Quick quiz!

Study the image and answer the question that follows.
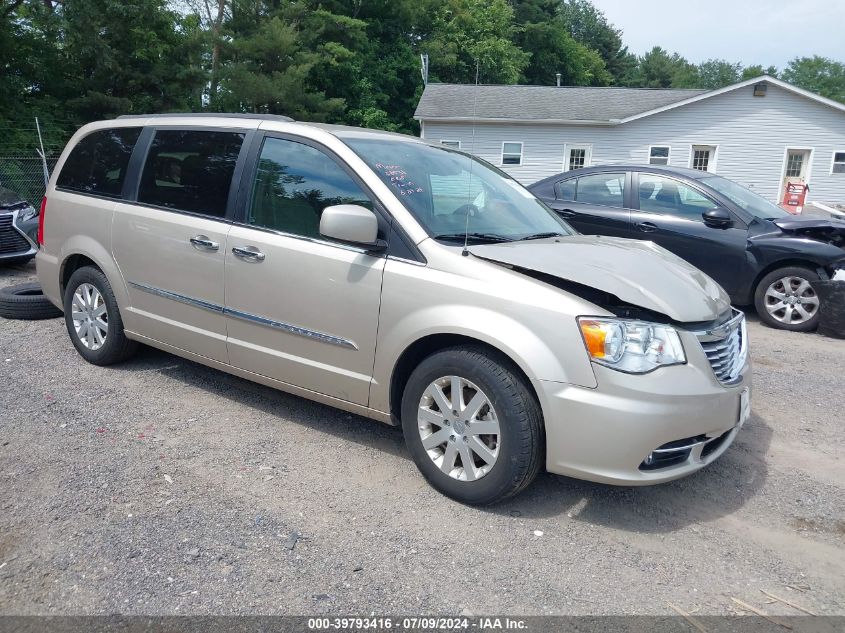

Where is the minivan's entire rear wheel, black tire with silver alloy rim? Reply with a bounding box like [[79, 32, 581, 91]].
[[64, 266, 138, 365]]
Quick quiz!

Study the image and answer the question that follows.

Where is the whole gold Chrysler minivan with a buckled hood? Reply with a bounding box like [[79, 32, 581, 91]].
[[37, 115, 751, 504]]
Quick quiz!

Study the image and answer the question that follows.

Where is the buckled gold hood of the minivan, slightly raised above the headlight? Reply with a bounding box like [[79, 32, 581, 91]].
[[469, 235, 730, 322]]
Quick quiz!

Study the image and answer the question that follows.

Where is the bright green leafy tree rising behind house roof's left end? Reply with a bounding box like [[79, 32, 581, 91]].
[[426, 0, 530, 84]]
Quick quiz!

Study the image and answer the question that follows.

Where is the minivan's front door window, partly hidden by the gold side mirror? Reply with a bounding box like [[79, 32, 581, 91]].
[[247, 138, 373, 237]]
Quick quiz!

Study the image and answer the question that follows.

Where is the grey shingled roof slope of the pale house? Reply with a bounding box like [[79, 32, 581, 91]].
[[414, 83, 707, 122]]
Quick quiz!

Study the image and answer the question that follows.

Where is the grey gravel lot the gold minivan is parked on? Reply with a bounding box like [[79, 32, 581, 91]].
[[0, 256, 845, 615]]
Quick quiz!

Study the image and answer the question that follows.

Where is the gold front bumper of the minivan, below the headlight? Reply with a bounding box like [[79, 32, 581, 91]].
[[534, 334, 751, 485]]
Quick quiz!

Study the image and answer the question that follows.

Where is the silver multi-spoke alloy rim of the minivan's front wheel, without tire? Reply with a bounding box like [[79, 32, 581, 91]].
[[417, 376, 500, 481]]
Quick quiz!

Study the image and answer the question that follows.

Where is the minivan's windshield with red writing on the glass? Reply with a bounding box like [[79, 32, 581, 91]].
[[343, 137, 575, 242]]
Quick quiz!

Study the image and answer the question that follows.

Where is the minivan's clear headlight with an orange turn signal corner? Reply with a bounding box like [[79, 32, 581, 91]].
[[578, 317, 687, 374]]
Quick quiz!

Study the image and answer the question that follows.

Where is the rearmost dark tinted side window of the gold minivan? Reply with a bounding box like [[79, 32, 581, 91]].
[[56, 127, 141, 198]]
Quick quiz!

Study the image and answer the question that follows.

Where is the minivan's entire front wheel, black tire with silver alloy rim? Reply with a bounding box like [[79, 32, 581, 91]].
[[402, 347, 544, 505]]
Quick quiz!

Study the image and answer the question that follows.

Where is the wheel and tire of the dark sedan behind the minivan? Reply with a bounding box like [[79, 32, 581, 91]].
[[754, 266, 819, 332]]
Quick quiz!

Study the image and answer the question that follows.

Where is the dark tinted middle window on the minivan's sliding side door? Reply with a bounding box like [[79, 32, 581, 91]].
[[138, 130, 244, 218]]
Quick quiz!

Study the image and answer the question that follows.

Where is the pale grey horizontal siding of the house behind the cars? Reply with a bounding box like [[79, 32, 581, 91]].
[[423, 84, 845, 203]]
